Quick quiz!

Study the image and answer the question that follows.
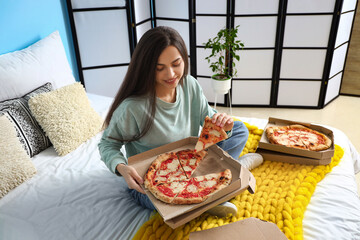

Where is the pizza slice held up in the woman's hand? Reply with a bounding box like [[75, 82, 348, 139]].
[[195, 116, 228, 151]]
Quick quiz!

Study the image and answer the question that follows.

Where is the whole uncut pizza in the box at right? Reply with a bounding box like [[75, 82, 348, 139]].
[[265, 125, 332, 151]]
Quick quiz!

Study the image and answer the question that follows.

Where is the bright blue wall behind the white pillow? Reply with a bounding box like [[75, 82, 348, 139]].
[[0, 0, 79, 81]]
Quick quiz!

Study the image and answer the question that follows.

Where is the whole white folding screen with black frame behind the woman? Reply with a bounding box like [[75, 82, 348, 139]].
[[68, 0, 357, 108]]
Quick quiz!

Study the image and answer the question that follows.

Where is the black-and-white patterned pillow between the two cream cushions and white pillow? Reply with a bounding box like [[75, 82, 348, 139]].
[[0, 83, 52, 157]]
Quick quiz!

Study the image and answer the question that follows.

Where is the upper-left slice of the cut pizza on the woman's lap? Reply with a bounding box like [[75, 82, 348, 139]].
[[144, 152, 187, 189]]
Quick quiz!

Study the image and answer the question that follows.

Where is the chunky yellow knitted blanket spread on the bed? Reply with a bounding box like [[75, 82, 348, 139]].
[[133, 122, 344, 240]]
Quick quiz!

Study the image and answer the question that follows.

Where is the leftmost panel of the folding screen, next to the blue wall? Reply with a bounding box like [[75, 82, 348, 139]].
[[67, 0, 132, 97]]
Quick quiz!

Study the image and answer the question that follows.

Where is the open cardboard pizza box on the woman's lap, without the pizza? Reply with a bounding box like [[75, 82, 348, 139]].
[[128, 137, 255, 228]]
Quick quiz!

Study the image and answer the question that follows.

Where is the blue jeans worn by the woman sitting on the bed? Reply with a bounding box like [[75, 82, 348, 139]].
[[129, 121, 249, 210]]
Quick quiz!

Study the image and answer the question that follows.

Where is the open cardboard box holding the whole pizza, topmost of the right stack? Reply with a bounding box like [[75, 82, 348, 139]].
[[258, 117, 335, 159]]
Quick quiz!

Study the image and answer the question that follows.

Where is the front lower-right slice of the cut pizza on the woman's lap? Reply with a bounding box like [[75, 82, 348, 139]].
[[172, 169, 232, 204]]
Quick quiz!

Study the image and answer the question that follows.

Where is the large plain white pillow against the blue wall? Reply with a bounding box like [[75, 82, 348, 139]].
[[0, 31, 75, 101]]
